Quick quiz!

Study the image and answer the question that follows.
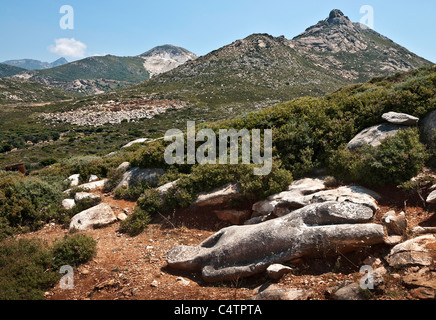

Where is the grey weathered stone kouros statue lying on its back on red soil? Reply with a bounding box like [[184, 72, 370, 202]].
[[167, 201, 385, 282]]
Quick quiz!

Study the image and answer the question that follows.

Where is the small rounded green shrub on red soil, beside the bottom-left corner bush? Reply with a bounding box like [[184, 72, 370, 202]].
[[52, 234, 97, 268]]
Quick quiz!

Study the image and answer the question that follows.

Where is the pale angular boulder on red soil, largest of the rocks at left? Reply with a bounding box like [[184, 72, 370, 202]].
[[70, 203, 117, 231]]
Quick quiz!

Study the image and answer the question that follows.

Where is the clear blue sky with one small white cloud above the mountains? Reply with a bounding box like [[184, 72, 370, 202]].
[[0, 0, 436, 62]]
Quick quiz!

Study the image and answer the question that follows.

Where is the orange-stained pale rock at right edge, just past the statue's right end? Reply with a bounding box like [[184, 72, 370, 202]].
[[386, 234, 436, 267]]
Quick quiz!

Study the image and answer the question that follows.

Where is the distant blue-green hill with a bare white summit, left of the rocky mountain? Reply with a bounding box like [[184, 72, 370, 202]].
[[5, 45, 197, 95]]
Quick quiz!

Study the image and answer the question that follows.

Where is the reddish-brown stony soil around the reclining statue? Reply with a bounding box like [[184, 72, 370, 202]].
[[13, 175, 436, 300]]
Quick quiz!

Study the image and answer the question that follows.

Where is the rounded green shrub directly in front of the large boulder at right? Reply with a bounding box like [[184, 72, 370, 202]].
[[330, 129, 427, 185]]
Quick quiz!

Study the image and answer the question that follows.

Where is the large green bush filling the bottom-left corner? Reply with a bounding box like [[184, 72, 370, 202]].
[[0, 239, 61, 300]]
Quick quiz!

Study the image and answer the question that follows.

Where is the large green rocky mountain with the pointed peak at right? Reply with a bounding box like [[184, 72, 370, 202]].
[[108, 10, 432, 117]]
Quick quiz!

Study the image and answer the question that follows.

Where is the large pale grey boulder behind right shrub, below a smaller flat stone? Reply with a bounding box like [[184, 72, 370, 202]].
[[347, 123, 408, 150]]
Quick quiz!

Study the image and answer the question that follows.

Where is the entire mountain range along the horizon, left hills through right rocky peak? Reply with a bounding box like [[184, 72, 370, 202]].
[[0, 10, 432, 105]]
